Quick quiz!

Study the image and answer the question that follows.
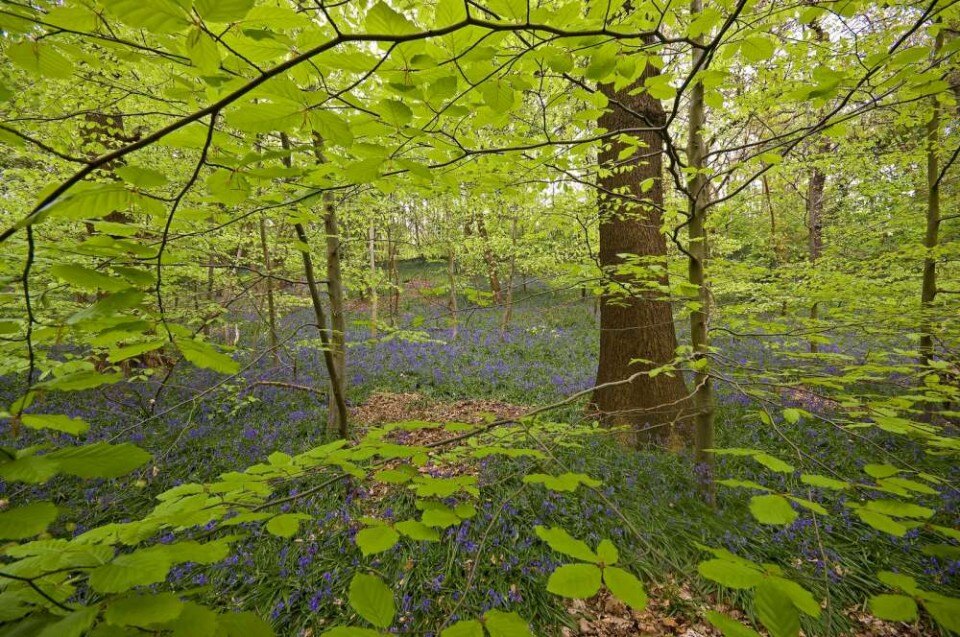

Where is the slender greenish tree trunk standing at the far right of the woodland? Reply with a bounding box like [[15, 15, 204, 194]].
[[920, 30, 943, 366]]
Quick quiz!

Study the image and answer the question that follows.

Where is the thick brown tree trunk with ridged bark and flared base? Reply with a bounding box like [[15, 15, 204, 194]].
[[593, 41, 689, 444]]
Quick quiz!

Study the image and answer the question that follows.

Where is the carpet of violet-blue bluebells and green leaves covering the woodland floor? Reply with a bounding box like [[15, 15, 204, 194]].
[[0, 264, 960, 634]]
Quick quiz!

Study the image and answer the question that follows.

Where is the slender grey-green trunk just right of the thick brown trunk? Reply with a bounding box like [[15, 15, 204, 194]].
[[687, 0, 716, 505]]
